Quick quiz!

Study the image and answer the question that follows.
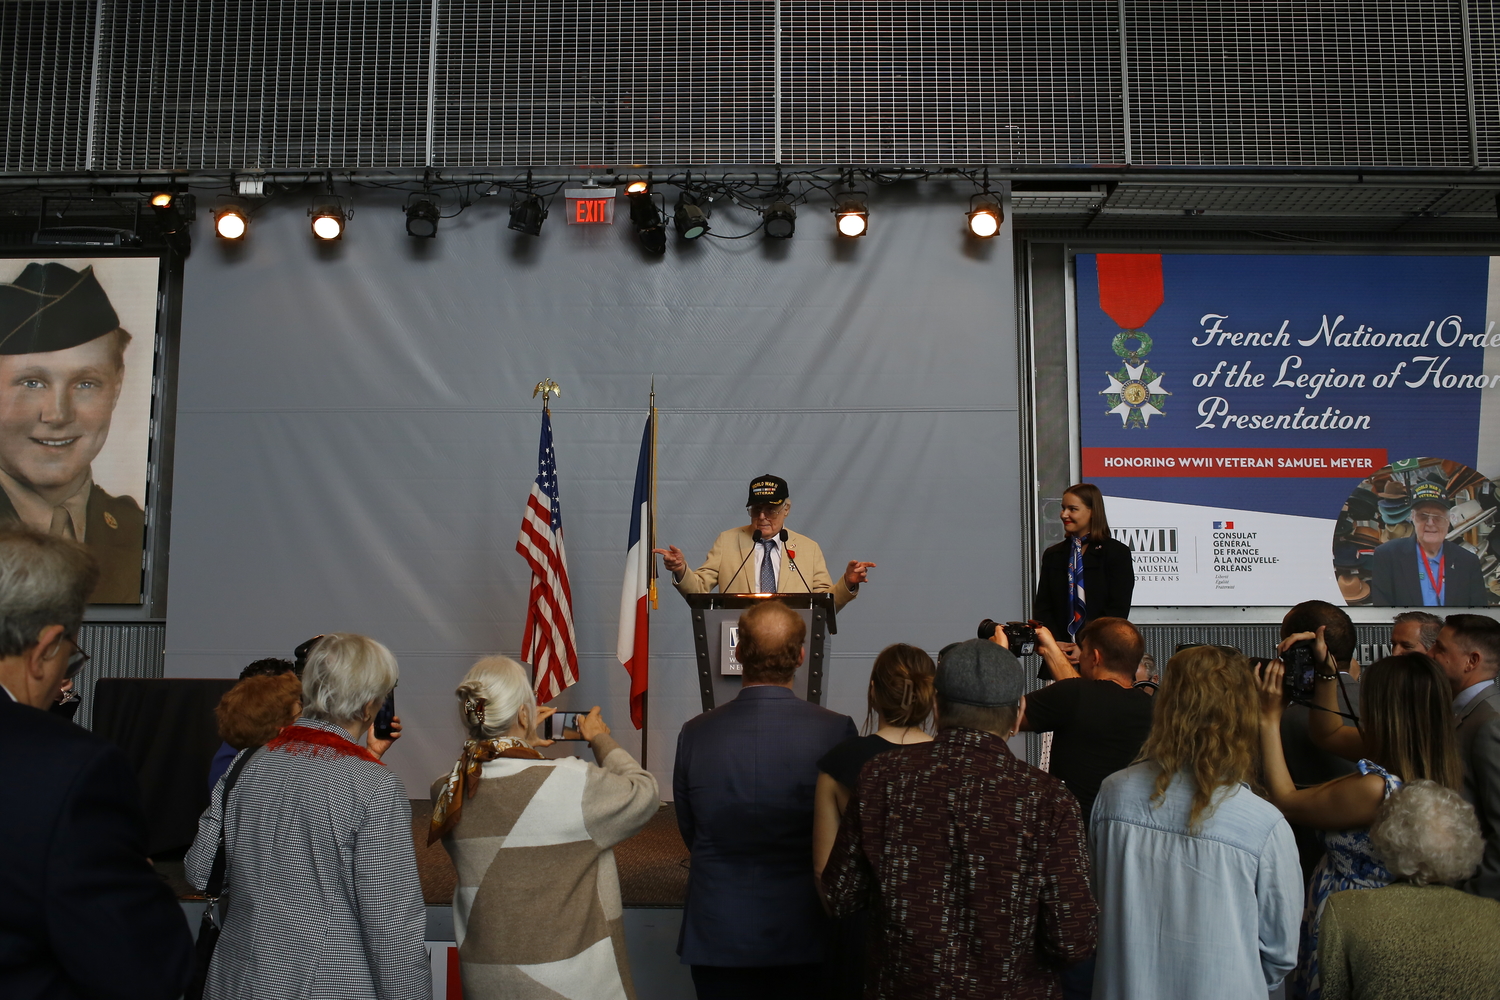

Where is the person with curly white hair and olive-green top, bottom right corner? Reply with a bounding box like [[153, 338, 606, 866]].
[[1319, 781, 1500, 1000]]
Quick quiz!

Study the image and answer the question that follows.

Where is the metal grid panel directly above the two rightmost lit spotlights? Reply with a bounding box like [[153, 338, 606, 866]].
[[783, 0, 1124, 163]]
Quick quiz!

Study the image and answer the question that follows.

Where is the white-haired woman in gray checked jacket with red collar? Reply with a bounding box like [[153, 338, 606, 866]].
[[188, 633, 432, 1000]]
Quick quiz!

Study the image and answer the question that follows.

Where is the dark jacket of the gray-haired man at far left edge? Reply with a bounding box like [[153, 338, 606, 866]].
[[0, 691, 192, 1000]]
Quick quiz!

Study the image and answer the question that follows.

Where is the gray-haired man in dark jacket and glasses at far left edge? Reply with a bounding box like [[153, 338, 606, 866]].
[[0, 528, 192, 1000]]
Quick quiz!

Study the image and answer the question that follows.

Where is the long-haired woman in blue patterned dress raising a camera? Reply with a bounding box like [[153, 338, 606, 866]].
[[1257, 641, 1463, 1000]]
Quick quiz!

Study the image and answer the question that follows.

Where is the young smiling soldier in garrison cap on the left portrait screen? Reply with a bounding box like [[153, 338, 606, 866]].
[[0, 262, 146, 604]]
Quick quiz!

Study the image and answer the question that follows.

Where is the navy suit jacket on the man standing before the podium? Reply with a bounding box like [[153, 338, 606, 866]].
[[672, 687, 857, 966]]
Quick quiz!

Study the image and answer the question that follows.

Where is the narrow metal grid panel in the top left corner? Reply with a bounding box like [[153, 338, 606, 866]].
[[0, 1, 95, 172]]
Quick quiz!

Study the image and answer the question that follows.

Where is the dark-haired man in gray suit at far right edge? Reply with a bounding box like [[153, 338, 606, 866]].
[[1433, 615, 1500, 900]]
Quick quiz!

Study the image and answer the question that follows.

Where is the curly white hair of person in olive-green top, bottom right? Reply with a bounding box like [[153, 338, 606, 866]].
[[1370, 781, 1485, 886]]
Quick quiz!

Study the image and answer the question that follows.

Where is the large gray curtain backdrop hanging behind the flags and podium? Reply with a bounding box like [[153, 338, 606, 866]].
[[167, 186, 1026, 798]]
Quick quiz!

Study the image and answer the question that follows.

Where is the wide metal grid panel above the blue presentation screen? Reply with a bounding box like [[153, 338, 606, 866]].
[[1125, 0, 1470, 166]]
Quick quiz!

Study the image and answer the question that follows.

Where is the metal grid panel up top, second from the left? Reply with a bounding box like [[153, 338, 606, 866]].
[[93, 0, 431, 169]]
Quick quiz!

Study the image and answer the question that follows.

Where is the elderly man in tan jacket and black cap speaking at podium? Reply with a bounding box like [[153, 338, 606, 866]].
[[654, 475, 875, 610]]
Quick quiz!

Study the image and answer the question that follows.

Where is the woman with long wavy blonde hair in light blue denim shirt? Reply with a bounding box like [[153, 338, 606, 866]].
[[1089, 646, 1302, 1000]]
